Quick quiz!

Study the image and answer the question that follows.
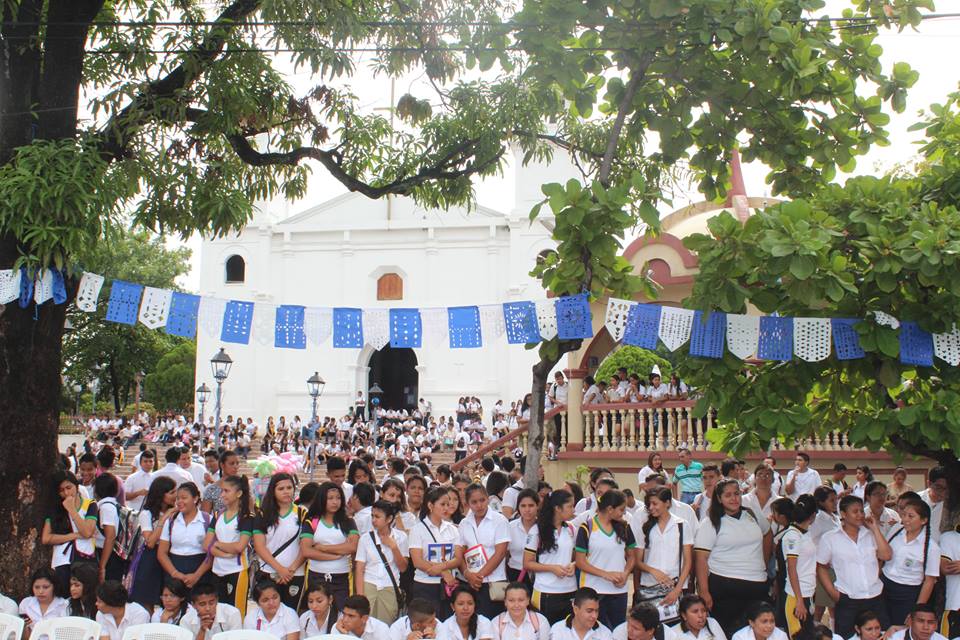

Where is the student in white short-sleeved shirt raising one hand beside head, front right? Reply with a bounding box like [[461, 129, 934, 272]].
[[817, 495, 893, 638]]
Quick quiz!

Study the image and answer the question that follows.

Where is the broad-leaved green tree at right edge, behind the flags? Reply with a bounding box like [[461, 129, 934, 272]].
[[681, 94, 960, 528]]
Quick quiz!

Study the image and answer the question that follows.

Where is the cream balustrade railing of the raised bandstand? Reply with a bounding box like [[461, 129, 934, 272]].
[[572, 400, 854, 452]]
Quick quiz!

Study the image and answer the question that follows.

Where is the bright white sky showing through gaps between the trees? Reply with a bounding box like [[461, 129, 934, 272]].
[[169, 6, 960, 291]]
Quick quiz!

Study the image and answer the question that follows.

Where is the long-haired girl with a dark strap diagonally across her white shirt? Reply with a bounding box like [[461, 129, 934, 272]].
[[253, 473, 307, 610]]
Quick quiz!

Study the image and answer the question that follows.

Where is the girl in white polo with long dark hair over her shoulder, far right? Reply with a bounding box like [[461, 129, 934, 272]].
[[880, 497, 940, 624]]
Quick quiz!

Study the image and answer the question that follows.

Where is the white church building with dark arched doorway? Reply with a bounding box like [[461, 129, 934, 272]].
[[196, 151, 577, 424]]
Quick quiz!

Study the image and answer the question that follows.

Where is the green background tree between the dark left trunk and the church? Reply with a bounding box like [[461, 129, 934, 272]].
[[63, 230, 193, 413]]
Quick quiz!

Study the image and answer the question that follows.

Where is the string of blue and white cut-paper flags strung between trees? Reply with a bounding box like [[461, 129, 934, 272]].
[[7, 269, 960, 367]]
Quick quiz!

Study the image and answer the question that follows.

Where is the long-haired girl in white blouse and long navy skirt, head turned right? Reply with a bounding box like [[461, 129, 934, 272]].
[[130, 476, 178, 611]]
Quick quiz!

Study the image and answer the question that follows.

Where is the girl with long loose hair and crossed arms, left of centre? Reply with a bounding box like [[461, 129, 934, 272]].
[[300, 482, 360, 611]]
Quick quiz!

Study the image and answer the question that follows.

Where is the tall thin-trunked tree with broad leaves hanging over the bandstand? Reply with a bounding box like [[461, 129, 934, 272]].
[[506, 0, 932, 486]]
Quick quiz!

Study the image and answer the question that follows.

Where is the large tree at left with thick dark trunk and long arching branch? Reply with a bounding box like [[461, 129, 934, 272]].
[[0, 0, 556, 595]]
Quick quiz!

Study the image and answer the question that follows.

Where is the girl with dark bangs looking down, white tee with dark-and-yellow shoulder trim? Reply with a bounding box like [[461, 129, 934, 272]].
[[576, 489, 637, 629]]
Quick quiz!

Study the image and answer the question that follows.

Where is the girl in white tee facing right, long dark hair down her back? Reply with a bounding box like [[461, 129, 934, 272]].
[[523, 489, 577, 625]]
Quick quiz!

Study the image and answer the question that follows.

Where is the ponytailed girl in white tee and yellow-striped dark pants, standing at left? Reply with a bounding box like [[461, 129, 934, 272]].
[[203, 476, 253, 615]]
